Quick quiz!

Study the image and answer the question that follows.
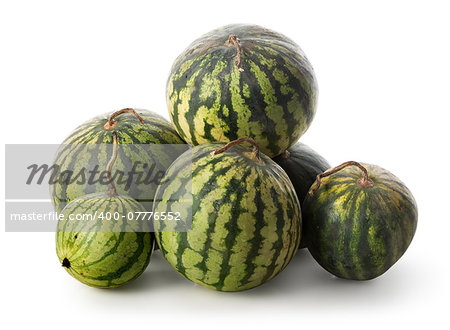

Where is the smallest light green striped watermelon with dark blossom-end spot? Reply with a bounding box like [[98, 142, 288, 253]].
[[56, 193, 153, 288]]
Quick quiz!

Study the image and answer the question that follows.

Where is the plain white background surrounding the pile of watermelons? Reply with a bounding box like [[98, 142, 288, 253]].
[[0, 0, 450, 329]]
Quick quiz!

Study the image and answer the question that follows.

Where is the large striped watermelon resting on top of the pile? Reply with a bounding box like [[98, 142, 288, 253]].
[[166, 24, 318, 157]]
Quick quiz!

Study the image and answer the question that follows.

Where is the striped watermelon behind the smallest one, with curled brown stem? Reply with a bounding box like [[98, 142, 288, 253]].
[[50, 109, 186, 212]]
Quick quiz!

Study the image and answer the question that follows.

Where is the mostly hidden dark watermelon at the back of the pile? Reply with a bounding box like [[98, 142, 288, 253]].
[[273, 142, 331, 249]]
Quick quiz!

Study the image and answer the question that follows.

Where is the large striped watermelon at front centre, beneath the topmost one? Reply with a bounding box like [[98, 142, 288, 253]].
[[154, 139, 301, 291]]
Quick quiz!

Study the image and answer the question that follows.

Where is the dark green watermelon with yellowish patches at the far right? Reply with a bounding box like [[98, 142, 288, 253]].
[[303, 162, 417, 280]]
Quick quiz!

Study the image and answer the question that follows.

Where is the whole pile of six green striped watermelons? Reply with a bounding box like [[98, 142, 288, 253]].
[[51, 25, 418, 291]]
